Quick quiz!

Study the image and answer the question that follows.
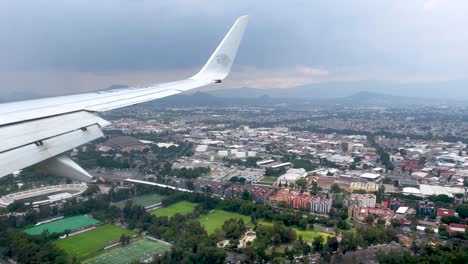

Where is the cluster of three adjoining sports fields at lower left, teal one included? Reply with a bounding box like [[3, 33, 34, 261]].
[[24, 215, 171, 263]]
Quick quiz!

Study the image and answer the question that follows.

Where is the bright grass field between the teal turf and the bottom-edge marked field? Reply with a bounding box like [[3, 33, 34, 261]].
[[54, 225, 135, 260]]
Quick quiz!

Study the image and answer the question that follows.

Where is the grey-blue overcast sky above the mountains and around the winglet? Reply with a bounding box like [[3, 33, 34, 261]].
[[0, 0, 468, 97]]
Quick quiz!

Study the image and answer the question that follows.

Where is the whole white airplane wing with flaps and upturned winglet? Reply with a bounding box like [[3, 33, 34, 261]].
[[0, 16, 248, 182]]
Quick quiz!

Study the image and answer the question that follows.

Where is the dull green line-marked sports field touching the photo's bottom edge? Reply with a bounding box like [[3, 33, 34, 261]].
[[84, 238, 171, 264]]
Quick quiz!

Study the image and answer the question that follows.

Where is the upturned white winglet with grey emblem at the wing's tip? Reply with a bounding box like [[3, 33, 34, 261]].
[[190, 16, 249, 82]]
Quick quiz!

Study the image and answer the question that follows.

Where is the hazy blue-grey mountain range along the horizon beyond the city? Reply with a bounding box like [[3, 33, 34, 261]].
[[0, 81, 468, 106]]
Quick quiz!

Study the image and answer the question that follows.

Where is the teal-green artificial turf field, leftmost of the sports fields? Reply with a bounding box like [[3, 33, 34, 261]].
[[24, 215, 100, 235]]
